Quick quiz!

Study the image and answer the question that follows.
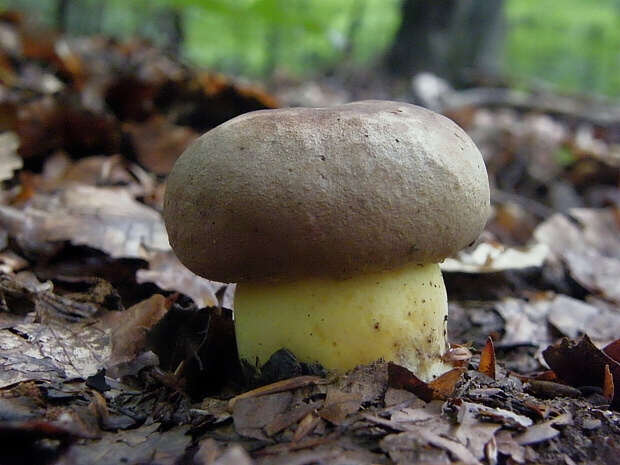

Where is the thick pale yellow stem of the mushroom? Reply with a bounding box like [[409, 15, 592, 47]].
[[234, 264, 451, 381]]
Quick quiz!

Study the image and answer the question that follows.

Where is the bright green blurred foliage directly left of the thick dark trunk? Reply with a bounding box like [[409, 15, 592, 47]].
[[175, 0, 400, 76]]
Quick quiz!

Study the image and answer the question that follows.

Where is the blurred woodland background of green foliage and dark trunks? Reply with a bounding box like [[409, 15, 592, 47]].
[[0, 0, 620, 97]]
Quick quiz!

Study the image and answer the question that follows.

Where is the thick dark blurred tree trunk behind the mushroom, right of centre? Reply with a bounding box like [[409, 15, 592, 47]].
[[384, 0, 505, 85]]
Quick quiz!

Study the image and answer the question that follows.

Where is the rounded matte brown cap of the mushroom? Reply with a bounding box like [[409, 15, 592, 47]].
[[164, 101, 489, 282]]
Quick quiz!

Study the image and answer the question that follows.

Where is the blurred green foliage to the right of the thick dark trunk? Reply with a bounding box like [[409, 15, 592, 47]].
[[506, 0, 620, 96]]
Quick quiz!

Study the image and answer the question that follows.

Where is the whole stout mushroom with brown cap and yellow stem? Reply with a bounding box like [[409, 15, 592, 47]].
[[164, 101, 489, 380]]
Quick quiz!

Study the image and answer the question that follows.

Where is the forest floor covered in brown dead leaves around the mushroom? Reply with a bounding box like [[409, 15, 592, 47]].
[[0, 15, 620, 465]]
